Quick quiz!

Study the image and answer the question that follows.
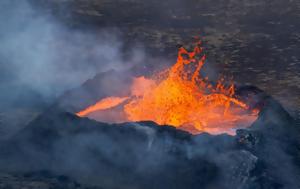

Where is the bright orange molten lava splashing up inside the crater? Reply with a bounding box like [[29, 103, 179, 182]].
[[77, 42, 257, 134]]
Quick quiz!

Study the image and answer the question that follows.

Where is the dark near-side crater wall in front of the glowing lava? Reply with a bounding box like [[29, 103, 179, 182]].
[[0, 86, 300, 189]]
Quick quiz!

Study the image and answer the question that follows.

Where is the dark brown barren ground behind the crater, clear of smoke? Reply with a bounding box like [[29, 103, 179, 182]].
[[32, 0, 300, 115]]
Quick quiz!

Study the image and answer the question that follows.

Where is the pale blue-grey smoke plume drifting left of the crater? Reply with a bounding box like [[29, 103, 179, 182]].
[[0, 0, 145, 137]]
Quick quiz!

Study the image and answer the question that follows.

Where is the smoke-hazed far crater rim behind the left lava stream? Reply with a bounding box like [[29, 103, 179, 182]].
[[52, 70, 132, 112]]
